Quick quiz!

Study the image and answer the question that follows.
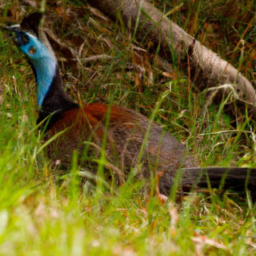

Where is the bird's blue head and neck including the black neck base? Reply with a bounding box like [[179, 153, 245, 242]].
[[15, 31, 79, 130]]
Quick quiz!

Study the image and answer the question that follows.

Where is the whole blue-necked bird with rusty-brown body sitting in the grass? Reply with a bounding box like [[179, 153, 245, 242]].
[[6, 13, 256, 200]]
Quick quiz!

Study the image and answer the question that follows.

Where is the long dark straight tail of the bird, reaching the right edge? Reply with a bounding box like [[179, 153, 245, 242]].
[[181, 167, 256, 202]]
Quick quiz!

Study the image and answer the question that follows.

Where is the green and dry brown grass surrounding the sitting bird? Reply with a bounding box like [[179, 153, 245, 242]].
[[0, 1, 256, 256]]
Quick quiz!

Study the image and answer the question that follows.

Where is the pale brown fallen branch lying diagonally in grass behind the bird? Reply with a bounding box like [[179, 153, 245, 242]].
[[88, 0, 256, 117]]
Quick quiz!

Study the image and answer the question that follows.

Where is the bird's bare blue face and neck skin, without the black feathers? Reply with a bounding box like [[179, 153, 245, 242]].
[[14, 30, 56, 107]]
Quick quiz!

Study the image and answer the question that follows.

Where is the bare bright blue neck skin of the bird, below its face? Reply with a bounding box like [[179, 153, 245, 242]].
[[30, 56, 56, 107]]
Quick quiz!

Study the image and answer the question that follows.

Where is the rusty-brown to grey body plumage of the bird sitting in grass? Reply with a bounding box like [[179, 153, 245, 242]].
[[48, 103, 195, 194]]
